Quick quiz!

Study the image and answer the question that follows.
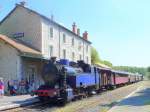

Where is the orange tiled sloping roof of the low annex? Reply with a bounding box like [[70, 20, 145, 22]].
[[0, 34, 41, 56]]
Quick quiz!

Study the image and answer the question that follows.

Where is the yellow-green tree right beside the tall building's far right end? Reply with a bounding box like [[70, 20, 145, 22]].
[[91, 47, 100, 64]]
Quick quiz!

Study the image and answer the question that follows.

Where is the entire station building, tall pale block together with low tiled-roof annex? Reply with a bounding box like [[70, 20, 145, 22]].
[[0, 4, 91, 92]]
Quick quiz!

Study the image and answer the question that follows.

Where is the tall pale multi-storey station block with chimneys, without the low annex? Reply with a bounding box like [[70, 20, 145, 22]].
[[0, 5, 91, 64]]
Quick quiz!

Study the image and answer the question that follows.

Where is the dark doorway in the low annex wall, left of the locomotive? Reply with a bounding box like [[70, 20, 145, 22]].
[[27, 66, 36, 89]]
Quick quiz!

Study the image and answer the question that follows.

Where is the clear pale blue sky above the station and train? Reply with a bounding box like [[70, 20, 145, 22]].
[[0, 0, 150, 67]]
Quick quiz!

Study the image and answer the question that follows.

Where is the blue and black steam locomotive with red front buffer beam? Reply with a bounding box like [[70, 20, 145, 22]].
[[34, 58, 99, 103]]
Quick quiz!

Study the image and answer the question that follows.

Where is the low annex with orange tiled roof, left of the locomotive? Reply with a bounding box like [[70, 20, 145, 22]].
[[0, 34, 43, 91]]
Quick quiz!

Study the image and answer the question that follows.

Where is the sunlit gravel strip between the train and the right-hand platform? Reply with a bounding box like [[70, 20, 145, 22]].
[[52, 82, 144, 112]]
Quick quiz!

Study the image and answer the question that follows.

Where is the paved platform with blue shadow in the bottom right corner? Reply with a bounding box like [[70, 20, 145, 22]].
[[108, 81, 150, 112]]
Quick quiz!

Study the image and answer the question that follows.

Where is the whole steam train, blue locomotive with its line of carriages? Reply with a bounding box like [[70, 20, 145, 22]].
[[34, 58, 143, 104]]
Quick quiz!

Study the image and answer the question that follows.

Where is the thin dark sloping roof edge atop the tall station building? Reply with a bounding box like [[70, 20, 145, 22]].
[[0, 4, 91, 44]]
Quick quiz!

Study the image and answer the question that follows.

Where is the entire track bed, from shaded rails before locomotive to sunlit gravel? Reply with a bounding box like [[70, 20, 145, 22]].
[[3, 82, 143, 112]]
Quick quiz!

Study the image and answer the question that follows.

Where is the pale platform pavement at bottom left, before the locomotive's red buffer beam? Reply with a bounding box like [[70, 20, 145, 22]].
[[0, 95, 39, 111]]
